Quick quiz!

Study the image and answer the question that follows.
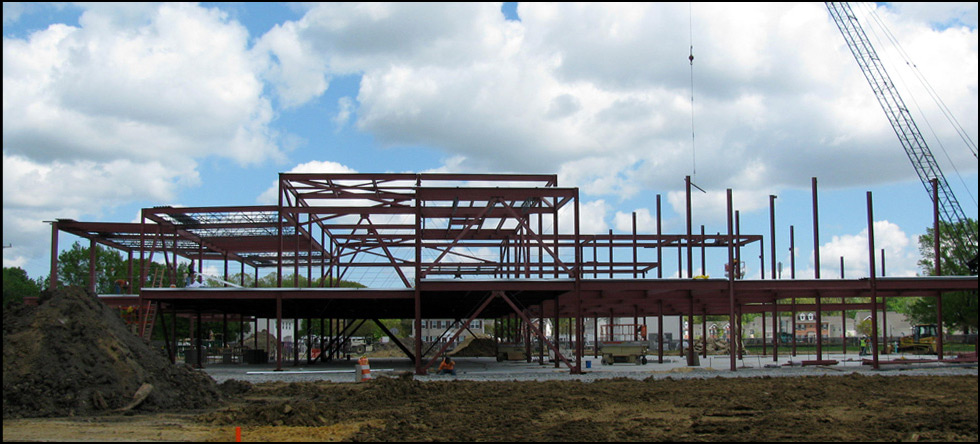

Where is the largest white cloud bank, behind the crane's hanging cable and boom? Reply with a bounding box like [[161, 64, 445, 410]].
[[256, 3, 977, 198]]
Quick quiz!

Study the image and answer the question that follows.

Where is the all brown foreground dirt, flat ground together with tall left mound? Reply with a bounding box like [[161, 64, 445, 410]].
[[3, 289, 978, 442]]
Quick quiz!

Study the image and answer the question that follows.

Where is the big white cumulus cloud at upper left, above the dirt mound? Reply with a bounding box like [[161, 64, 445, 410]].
[[3, 4, 282, 270]]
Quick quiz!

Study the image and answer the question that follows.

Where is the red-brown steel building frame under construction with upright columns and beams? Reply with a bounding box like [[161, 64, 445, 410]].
[[51, 173, 977, 374]]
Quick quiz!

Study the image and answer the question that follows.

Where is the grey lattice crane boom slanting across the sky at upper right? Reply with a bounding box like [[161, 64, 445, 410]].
[[825, 2, 977, 263]]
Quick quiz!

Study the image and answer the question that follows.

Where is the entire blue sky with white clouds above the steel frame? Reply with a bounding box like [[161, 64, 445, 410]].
[[3, 3, 978, 284]]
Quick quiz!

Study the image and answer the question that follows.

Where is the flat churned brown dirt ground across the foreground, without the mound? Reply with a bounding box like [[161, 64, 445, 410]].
[[3, 374, 978, 442]]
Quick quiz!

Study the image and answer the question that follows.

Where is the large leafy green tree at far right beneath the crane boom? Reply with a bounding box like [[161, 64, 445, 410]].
[[909, 219, 977, 332]]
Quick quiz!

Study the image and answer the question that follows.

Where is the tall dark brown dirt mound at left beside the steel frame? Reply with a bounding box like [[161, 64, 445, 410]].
[[3, 287, 219, 418]]
